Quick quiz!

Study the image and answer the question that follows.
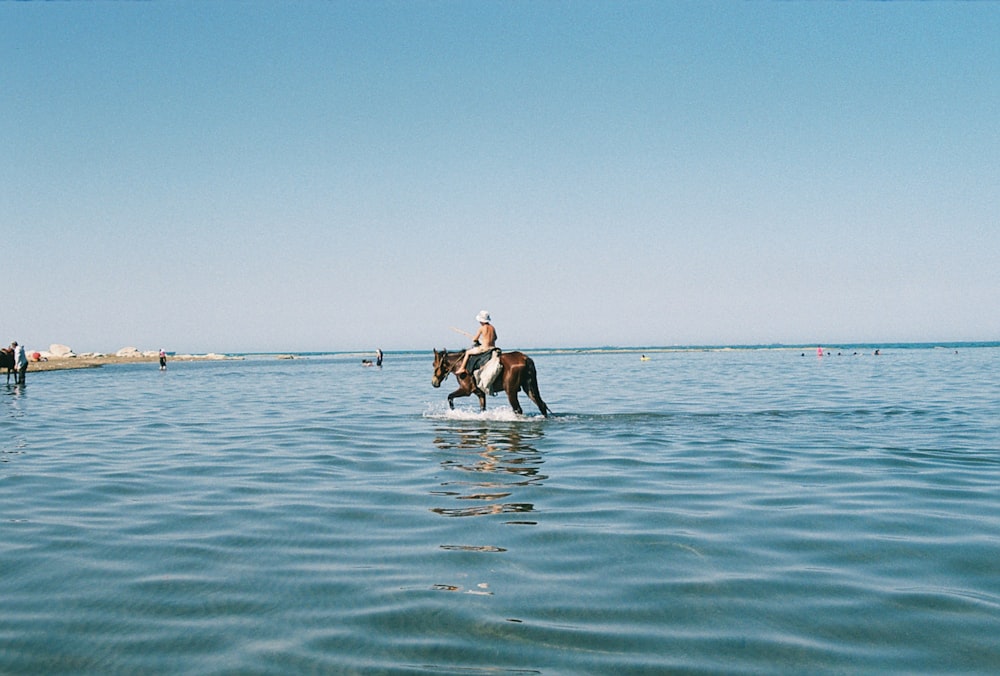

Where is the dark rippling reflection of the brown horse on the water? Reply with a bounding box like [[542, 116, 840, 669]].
[[431, 425, 548, 525]]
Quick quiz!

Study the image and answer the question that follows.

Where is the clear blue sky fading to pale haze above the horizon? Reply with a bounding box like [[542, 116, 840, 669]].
[[0, 0, 1000, 352]]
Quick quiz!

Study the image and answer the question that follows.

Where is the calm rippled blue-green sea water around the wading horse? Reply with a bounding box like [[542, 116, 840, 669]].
[[0, 345, 1000, 674]]
